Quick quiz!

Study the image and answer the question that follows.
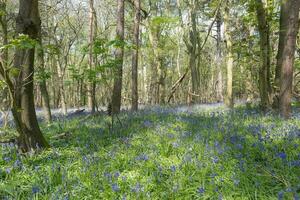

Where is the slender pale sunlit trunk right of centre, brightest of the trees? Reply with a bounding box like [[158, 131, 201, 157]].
[[224, 0, 234, 108]]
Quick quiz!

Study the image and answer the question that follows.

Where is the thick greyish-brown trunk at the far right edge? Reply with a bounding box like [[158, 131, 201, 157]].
[[278, 0, 300, 118]]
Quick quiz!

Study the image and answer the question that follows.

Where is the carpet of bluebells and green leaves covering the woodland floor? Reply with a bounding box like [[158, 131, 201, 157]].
[[0, 106, 300, 200]]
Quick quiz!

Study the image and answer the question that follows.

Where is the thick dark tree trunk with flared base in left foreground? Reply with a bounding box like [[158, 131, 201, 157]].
[[10, 0, 49, 152]]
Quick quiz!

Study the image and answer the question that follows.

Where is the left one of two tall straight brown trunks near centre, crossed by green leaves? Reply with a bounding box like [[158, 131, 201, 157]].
[[112, 0, 124, 114]]
